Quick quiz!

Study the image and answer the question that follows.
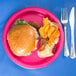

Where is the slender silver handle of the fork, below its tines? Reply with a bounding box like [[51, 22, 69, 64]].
[[64, 24, 69, 57]]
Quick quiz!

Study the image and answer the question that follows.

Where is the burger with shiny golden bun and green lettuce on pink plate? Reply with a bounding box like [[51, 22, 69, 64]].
[[7, 20, 38, 56]]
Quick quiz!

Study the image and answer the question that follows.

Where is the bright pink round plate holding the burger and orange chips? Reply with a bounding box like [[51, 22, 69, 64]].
[[2, 7, 64, 69]]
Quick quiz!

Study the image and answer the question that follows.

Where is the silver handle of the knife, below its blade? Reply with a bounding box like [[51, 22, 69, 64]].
[[70, 30, 75, 59]]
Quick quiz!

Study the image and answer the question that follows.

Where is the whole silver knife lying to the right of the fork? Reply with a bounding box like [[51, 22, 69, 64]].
[[69, 7, 75, 59]]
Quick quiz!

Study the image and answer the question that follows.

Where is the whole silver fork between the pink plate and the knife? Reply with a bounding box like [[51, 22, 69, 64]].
[[61, 8, 69, 57]]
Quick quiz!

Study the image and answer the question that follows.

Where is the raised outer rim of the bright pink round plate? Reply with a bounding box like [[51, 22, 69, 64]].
[[2, 7, 64, 69]]
